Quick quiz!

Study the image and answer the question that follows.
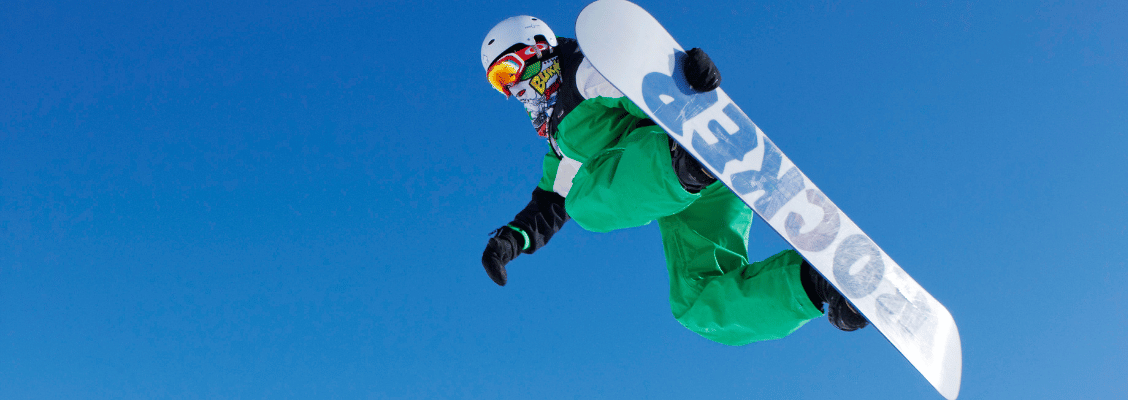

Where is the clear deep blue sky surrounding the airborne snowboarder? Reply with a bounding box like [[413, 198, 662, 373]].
[[0, 1, 1128, 399]]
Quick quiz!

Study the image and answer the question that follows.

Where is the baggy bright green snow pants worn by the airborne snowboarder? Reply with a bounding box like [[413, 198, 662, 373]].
[[565, 126, 822, 346]]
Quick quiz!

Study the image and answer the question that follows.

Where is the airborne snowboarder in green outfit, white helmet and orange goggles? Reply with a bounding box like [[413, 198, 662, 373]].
[[482, 16, 867, 345]]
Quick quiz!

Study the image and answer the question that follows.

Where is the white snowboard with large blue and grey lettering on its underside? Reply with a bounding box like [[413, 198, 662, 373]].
[[575, 0, 962, 399]]
